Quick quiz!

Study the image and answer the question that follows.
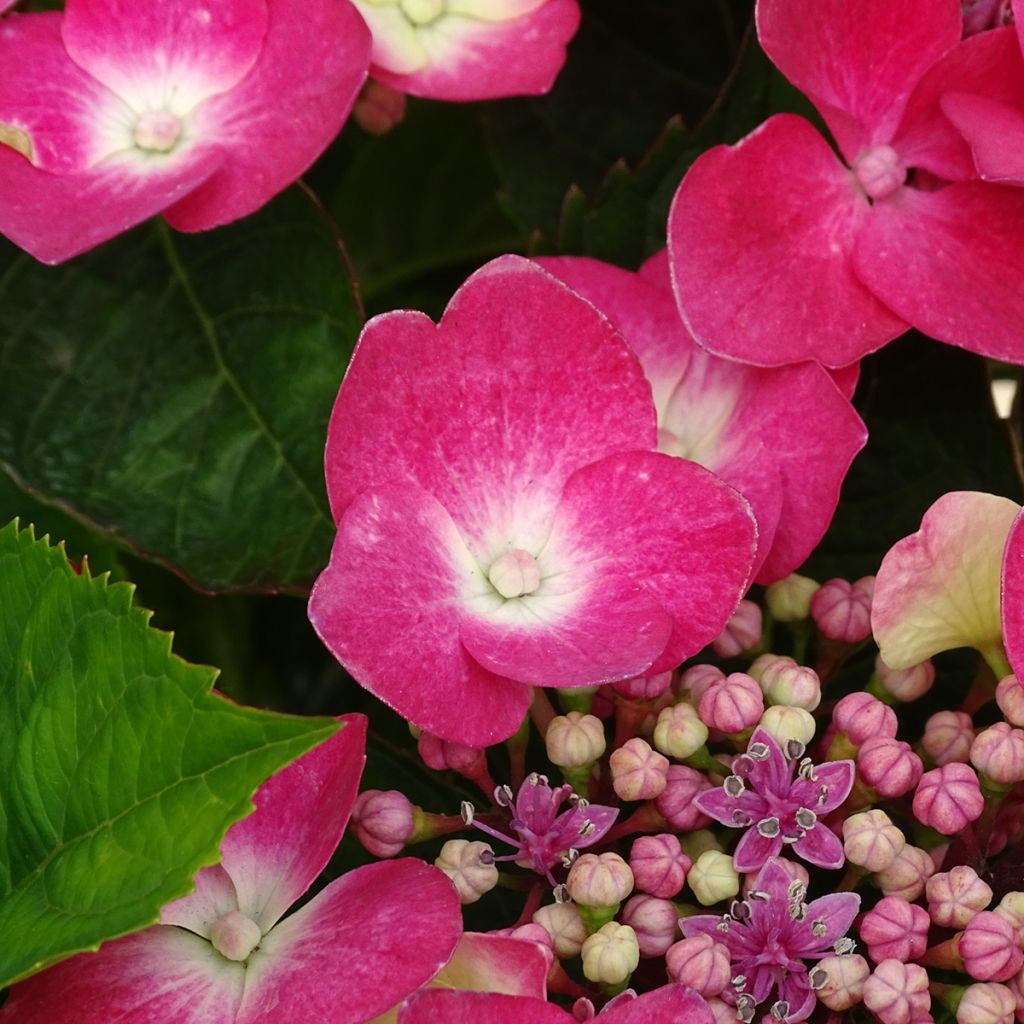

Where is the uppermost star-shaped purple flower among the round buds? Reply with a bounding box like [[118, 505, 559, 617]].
[[694, 728, 854, 872]]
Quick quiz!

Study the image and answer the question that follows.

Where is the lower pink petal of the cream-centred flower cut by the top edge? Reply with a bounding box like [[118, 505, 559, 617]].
[[371, 0, 580, 100]]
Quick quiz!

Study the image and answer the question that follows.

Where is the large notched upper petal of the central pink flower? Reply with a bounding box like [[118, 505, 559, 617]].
[[326, 256, 656, 552]]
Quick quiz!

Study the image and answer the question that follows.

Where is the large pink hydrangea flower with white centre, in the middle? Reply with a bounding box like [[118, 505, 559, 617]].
[[309, 256, 755, 746]]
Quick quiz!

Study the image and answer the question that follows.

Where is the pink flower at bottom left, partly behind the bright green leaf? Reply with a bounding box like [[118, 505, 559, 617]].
[[3, 715, 462, 1024]]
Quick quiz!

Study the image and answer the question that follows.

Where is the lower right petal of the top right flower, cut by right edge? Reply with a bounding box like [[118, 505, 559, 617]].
[[854, 182, 1024, 362]]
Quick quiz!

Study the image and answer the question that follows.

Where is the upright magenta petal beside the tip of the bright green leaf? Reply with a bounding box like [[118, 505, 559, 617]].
[[214, 715, 367, 933]]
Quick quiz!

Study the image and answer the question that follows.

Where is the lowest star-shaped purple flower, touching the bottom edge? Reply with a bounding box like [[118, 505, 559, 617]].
[[682, 857, 860, 1024]]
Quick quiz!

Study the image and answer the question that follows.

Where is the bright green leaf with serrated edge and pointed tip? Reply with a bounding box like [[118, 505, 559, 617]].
[[0, 522, 337, 987]]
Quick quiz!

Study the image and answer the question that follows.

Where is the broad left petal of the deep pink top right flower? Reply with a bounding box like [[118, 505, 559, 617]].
[[669, 115, 906, 367]]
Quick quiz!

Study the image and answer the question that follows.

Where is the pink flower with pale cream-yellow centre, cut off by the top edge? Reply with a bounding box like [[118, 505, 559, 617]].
[[352, 0, 580, 100]]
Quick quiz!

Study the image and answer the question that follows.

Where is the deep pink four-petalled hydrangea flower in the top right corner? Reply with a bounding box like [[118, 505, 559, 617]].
[[669, 0, 1024, 367]]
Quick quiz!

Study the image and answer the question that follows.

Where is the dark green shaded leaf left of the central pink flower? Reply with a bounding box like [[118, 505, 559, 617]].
[[0, 190, 360, 592]]
